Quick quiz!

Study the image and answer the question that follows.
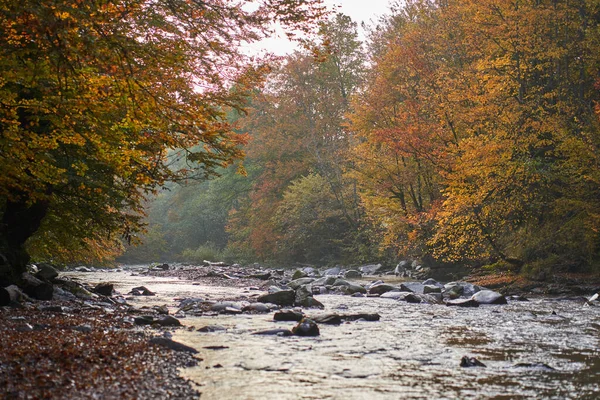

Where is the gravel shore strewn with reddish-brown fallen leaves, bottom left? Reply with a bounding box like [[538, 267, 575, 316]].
[[0, 302, 200, 399]]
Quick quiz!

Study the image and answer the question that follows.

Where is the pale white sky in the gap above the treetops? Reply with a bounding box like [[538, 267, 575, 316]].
[[244, 0, 391, 55]]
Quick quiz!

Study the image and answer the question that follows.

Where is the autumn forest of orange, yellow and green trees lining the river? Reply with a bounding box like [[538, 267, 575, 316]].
[[0, 0, 600, 282]]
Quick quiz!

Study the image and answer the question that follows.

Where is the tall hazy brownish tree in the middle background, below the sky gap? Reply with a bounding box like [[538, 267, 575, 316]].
[[229, 14, 364, 261]]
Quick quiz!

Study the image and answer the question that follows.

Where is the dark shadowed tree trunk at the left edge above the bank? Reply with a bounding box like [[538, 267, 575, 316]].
[[0, 196, 48, 286]]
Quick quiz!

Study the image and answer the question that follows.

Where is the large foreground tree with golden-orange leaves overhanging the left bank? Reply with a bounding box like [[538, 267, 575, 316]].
[[0, 0, 323, 280]]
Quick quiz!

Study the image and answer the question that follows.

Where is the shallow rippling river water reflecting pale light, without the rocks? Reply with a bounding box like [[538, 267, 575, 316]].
[[64, 272, 600, 399]]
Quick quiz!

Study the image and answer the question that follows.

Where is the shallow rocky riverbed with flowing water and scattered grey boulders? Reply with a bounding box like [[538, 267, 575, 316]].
[[0, 264, 600, 399]]
